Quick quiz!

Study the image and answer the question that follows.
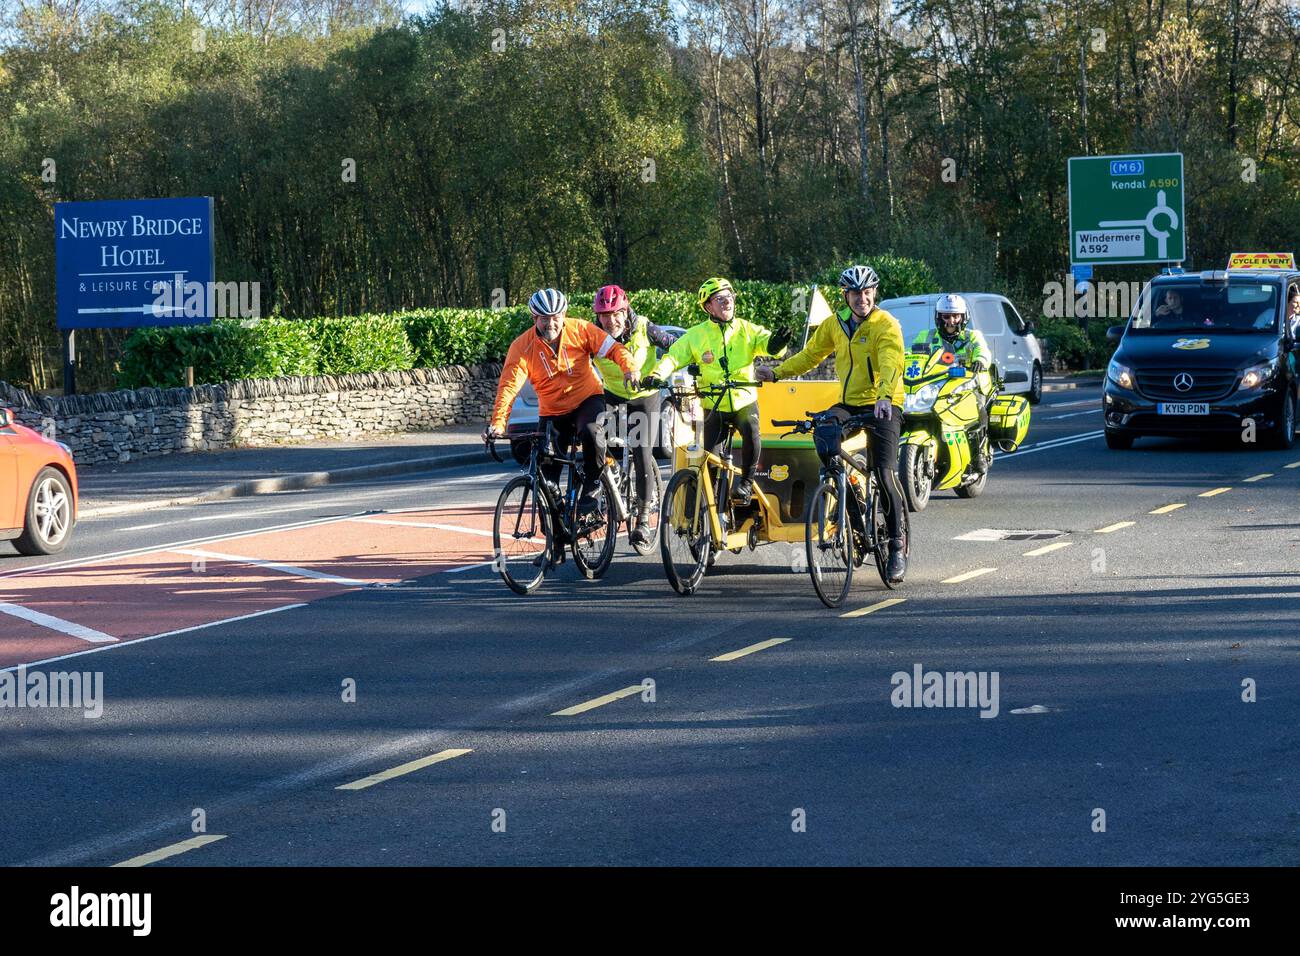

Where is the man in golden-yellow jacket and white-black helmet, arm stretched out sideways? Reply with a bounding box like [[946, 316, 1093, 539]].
[[758, 265, 907, 581]]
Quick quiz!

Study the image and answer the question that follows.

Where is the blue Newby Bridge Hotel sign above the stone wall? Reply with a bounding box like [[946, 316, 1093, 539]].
[[55, 196, 213, 329]]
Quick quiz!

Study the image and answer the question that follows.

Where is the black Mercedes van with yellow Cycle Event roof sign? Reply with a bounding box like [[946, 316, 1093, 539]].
[[1102, 269, 1300, 449]]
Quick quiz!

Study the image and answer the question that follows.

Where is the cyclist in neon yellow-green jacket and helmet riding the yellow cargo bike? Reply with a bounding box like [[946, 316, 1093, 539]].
[[650, 278, 787, 501]]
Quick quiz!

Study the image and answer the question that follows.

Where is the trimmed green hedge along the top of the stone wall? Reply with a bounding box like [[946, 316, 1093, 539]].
[[117, 256, 936, 389]]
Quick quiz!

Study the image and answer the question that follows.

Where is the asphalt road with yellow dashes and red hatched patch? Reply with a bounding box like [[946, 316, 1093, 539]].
[[0, 388, 1300, 866]]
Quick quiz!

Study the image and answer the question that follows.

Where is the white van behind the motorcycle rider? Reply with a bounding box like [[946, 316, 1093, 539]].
[[878, 293, 1043, 405]]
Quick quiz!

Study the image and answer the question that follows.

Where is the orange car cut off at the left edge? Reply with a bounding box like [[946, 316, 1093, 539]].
[[0, 407, 77, 554]]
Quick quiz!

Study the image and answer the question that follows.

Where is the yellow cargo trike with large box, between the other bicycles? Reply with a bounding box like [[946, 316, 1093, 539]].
[[659, 369, 866, 594]]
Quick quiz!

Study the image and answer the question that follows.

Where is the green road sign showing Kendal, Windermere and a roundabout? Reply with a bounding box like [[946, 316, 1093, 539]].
[[1066, 152, 1187, 265]]
